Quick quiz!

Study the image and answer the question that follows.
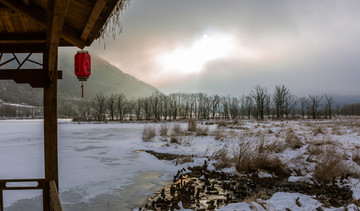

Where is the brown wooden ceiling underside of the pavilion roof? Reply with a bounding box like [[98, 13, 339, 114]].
[[0, 0, 119, 51]]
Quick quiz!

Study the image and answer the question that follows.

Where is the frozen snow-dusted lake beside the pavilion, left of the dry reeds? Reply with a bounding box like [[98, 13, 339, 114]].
[[0, 120, 178, 211]]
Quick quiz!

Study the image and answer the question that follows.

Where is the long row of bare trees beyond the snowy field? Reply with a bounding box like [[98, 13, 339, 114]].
[[74, 85, 334, 121]]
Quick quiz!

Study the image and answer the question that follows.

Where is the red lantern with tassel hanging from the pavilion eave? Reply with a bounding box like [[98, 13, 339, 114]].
[[75, 50, 91, 97]]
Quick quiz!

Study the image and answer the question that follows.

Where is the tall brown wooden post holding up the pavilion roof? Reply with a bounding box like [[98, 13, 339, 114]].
[[43, 0, 69, 211]]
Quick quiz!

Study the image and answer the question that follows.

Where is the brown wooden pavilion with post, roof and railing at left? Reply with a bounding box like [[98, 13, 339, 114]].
[[0, 0, 128, 211]]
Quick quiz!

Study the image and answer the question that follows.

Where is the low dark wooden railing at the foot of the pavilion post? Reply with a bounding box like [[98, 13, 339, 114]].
[[0, 179, 62, 211]]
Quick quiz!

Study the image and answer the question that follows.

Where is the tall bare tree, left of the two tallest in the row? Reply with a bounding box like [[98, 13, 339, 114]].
[[250, 85, 269, 120]]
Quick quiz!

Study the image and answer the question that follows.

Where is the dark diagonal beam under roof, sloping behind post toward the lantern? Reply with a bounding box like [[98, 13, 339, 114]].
[[0, 0, 85, 49]]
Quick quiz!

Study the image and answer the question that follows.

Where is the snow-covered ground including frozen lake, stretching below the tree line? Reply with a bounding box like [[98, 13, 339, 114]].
[[0, 118, 360, 211]]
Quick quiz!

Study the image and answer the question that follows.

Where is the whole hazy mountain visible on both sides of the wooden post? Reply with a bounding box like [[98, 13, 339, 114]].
[[0, 51, 157, 105]]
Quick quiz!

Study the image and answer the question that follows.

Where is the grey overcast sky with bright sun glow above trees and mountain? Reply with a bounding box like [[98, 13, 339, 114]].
[[89, 0, 360, 96]]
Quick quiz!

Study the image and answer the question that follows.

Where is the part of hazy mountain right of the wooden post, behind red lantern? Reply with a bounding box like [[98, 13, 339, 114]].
[[59, 53, 157, 98]]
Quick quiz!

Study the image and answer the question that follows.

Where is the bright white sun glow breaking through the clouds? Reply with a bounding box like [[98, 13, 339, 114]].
[[156, 34, 235, 74]]
